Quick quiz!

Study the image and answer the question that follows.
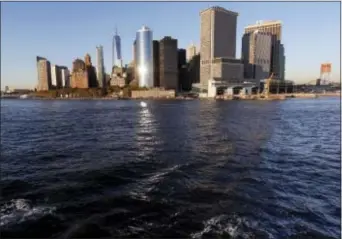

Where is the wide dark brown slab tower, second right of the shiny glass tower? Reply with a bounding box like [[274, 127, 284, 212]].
[[159, 36, 178, 90]]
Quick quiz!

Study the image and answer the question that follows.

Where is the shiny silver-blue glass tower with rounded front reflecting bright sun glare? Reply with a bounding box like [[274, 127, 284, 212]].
[[136, 26, 154, 87]]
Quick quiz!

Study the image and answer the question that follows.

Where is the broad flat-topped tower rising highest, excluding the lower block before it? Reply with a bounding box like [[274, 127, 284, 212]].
[[200, 7, 238, 86]]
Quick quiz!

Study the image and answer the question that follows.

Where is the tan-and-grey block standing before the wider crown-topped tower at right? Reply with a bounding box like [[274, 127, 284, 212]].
[[241, 30, 272, 82]]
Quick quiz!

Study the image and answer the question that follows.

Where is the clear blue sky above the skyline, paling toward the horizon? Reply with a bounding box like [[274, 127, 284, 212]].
[[1, 2, 341, 89]]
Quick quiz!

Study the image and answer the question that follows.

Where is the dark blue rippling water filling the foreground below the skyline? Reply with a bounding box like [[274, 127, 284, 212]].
[[0, 98, 341, 238]]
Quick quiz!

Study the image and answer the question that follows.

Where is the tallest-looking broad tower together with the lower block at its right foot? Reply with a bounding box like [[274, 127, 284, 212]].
[[200, 7, 243, 89]]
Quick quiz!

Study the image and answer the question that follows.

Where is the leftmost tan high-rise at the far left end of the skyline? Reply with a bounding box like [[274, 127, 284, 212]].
[[36, 56, 52, 91]]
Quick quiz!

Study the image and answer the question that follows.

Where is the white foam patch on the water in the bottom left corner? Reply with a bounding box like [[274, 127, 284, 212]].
[[0, 199, 55, 227]]
